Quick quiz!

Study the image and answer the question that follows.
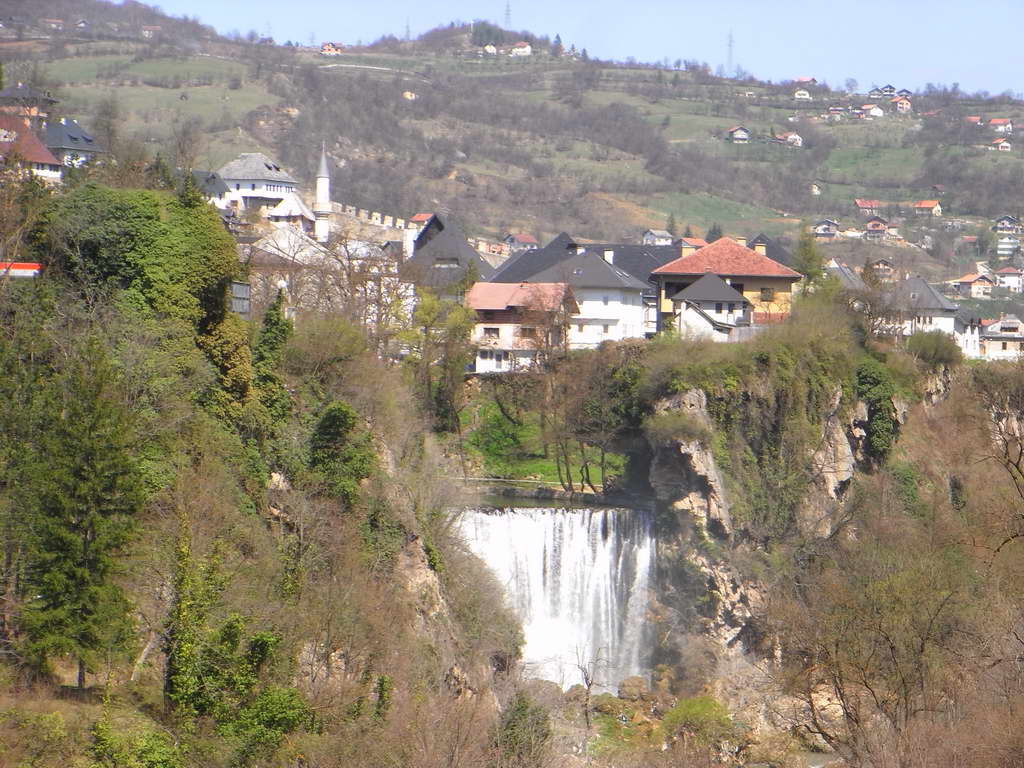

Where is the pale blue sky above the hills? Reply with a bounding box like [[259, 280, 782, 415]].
[[153, 0, 1024, 93]]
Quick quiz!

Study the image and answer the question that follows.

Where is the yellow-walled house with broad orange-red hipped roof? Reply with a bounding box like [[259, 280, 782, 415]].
[[651, 238, 801, 330]]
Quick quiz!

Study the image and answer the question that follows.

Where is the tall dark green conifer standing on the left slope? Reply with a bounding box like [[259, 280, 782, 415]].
[[20, 338, 144, 688]]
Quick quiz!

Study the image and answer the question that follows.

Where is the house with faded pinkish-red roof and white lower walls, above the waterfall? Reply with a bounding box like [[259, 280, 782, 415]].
[[465, 283, 580, 374]]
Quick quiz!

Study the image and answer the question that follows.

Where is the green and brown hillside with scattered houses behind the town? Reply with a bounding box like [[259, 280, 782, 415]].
[[8, 3, 1024, 270]]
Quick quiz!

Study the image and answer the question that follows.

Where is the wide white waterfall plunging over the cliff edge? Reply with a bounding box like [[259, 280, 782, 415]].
[[462, 507, 654, 690]]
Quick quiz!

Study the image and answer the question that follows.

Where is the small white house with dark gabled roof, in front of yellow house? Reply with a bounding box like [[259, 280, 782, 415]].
[[670, 272, 751, 341]]
